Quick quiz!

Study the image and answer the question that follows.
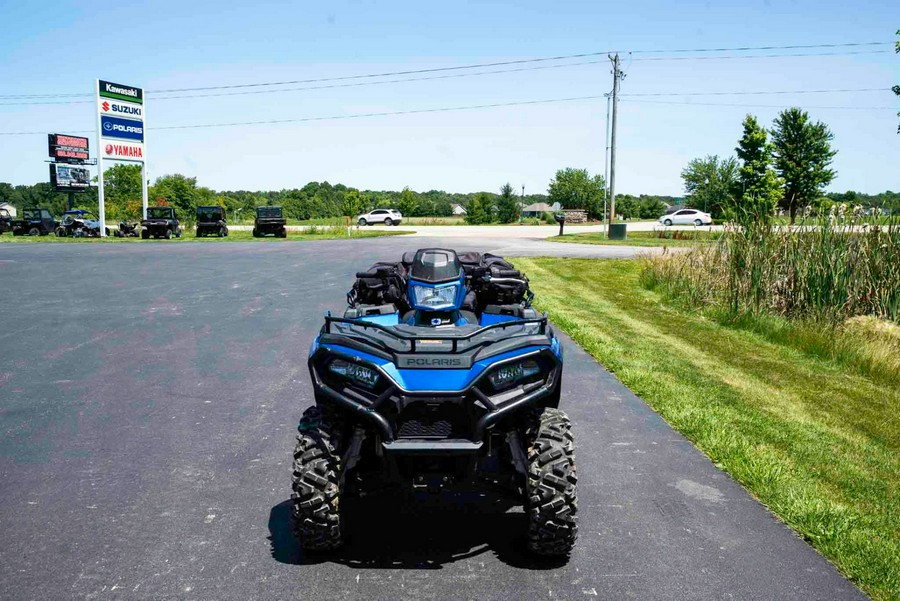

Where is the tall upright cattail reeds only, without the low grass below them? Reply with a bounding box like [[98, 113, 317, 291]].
[[643, 219, 900, 323]]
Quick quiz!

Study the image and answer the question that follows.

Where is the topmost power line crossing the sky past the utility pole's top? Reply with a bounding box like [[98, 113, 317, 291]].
[[0, 42, 893, 99]]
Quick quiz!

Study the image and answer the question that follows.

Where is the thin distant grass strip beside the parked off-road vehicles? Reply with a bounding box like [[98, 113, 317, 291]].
[[0, 228, 412, 244]]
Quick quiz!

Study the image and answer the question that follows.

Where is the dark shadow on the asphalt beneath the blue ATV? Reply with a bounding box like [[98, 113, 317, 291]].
[[269, 493, 568, 570]]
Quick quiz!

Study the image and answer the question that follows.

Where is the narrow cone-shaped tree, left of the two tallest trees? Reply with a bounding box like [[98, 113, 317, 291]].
[[725, 115, 783, 223]]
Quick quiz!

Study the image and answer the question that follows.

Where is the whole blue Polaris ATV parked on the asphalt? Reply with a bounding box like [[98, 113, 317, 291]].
[[292, 248, 577, 555]]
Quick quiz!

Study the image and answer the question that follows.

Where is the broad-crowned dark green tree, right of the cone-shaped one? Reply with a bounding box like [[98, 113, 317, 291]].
[[772, 108, 837, 224]]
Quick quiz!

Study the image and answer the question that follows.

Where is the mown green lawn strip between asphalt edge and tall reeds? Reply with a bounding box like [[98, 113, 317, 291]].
[[516, 258, 900, 599]]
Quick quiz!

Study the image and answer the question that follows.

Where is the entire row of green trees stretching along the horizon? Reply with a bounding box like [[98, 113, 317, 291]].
[[0, 149, 900, 224]]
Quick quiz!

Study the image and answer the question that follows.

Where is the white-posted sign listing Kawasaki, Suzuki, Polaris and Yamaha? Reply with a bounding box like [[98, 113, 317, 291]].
[[96, 79, 147, 235]]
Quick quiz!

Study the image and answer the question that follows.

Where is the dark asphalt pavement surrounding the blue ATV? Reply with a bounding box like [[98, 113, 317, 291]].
[[0, 238, 862, 601]]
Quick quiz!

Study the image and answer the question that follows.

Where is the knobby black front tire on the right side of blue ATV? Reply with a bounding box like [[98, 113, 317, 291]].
[[526, 408, 578, 556]]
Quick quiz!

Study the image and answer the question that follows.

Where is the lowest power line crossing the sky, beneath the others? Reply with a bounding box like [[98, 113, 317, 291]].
[[0, 94, 896, 136]]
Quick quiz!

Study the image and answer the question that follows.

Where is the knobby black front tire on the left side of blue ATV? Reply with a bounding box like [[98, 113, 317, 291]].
[[291, 407, 343, 551]]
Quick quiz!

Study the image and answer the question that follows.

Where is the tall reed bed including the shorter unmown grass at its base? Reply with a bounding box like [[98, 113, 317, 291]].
[[642, 215, 900, 383]]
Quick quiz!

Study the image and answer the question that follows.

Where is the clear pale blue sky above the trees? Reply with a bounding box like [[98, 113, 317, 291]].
[[0, 0, 900, 195]]
